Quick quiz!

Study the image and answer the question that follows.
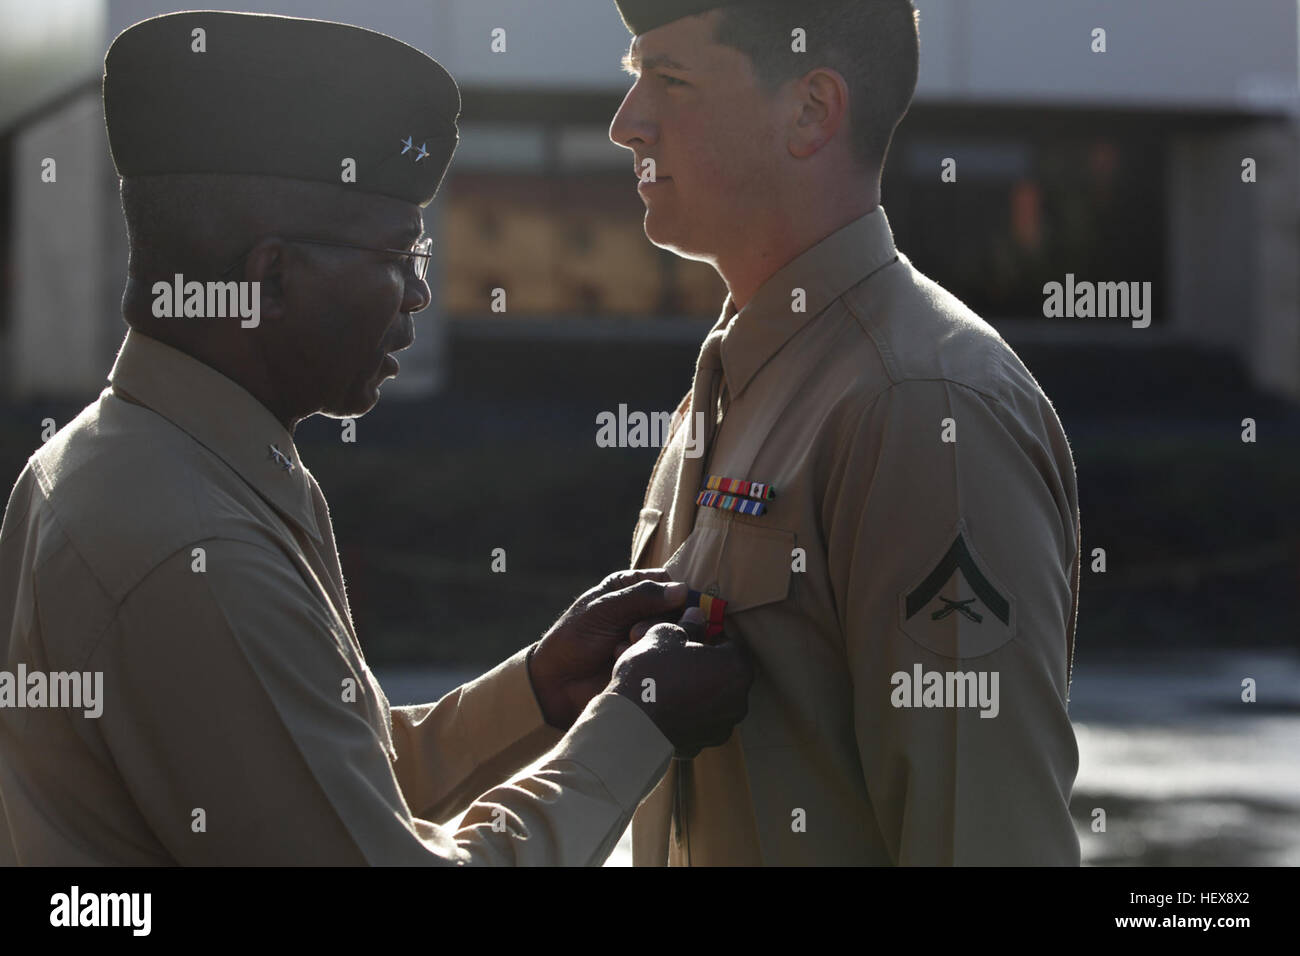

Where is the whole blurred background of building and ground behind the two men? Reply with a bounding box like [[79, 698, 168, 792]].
[[0, 0, 1300, 865]]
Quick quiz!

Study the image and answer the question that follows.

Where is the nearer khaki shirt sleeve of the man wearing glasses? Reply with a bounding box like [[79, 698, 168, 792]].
[[92, 540, 672, 865]]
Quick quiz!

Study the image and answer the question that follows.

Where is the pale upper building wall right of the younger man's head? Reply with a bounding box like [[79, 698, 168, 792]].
[[917, 0, 1300, 112]]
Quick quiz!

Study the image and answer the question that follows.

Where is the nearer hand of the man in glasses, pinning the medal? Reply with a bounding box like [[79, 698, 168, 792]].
[[610, 607, 754, 757]]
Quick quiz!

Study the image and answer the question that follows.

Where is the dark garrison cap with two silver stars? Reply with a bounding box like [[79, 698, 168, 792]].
[[104, 10, 460, 206]]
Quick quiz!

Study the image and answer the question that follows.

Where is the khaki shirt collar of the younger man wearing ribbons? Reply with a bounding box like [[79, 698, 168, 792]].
[[714, 206, 898, 398]]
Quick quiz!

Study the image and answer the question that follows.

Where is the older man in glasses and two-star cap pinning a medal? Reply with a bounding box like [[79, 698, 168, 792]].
[[0, 12, 749, 865]]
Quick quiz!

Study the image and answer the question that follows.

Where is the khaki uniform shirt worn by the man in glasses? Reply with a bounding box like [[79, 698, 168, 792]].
[[0, 332, 672, 865]]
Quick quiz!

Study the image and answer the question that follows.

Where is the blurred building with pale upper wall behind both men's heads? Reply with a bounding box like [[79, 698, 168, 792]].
[[0, 0, 1300, 398]]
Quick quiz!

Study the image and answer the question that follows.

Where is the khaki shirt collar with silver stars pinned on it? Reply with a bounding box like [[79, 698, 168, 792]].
[[108, 329, 322, 542]]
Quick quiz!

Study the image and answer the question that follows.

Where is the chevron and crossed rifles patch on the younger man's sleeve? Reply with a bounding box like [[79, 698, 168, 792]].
[[898, 522, 1015, 658]]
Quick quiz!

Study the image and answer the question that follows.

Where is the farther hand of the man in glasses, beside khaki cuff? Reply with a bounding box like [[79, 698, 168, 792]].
[[528, 568, 686, 730]]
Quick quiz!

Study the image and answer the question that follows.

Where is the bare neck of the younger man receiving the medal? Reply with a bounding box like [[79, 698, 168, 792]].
[[714, 180, 880, 311]]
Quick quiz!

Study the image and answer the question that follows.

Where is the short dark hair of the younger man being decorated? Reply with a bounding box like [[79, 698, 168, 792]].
[[714, 0, 920, 170]]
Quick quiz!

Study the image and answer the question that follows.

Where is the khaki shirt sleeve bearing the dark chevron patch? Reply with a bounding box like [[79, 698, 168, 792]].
[[823, 380, 1079, 865]]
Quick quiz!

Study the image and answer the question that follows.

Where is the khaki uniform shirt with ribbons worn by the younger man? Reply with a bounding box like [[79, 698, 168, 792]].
[[632, 207, 1080, 865]]
